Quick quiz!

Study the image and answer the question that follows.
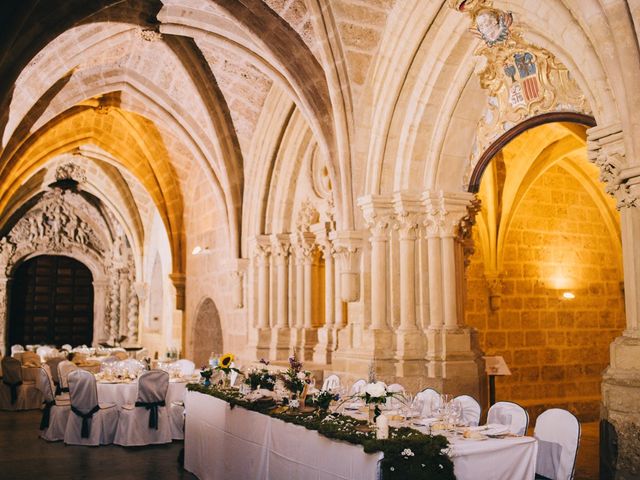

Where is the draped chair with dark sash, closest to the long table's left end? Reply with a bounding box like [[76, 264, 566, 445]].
[[114, 370, 171, 447]]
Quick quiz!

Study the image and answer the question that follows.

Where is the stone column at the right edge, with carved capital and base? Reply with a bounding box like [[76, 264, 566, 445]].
[[587, 125, 640, 479]]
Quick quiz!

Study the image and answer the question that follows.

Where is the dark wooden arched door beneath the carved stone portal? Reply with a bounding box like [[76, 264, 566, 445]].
[[8, 255, 93, 346]]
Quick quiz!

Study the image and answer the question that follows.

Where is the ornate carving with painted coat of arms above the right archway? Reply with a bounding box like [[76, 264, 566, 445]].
[[450, 0, 591, 188]]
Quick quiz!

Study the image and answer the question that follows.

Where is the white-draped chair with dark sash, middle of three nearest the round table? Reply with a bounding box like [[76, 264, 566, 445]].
[[64, 369, 118, 445]]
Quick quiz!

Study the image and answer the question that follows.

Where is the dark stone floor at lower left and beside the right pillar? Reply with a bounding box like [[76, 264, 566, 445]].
[[0, 411, 598, 480]]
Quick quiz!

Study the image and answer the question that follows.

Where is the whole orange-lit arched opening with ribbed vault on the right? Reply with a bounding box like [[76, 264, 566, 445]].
[[465, 119, 625, 421]]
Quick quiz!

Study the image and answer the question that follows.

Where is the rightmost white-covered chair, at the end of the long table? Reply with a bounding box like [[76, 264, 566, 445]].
[[533, 408, 580, 480]]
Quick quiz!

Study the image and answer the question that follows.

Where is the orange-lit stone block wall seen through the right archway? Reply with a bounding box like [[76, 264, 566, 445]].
[[466, 166, 625, 419]]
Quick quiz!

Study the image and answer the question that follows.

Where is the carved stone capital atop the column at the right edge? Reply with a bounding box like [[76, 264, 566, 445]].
[[587, 125, 640, 210]]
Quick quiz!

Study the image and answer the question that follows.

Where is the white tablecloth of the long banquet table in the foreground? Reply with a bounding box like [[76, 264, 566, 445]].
[[184, 392, 538, 480]]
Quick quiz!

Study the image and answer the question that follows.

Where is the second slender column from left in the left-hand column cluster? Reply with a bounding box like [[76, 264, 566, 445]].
[[270, 234, 291, 360]]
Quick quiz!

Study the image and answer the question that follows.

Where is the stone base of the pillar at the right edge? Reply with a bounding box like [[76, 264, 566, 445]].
[[600, 336, 640, 479]]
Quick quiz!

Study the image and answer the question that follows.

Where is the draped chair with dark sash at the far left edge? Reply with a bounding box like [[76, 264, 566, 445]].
[[0, 357, 42, 410]]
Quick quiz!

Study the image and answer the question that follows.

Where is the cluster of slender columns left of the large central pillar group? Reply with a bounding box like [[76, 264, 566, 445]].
[[249, 223, 345, 364]]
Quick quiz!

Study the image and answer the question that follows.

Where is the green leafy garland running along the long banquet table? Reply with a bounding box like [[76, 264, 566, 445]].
[[187, 383, 455, 480]]
